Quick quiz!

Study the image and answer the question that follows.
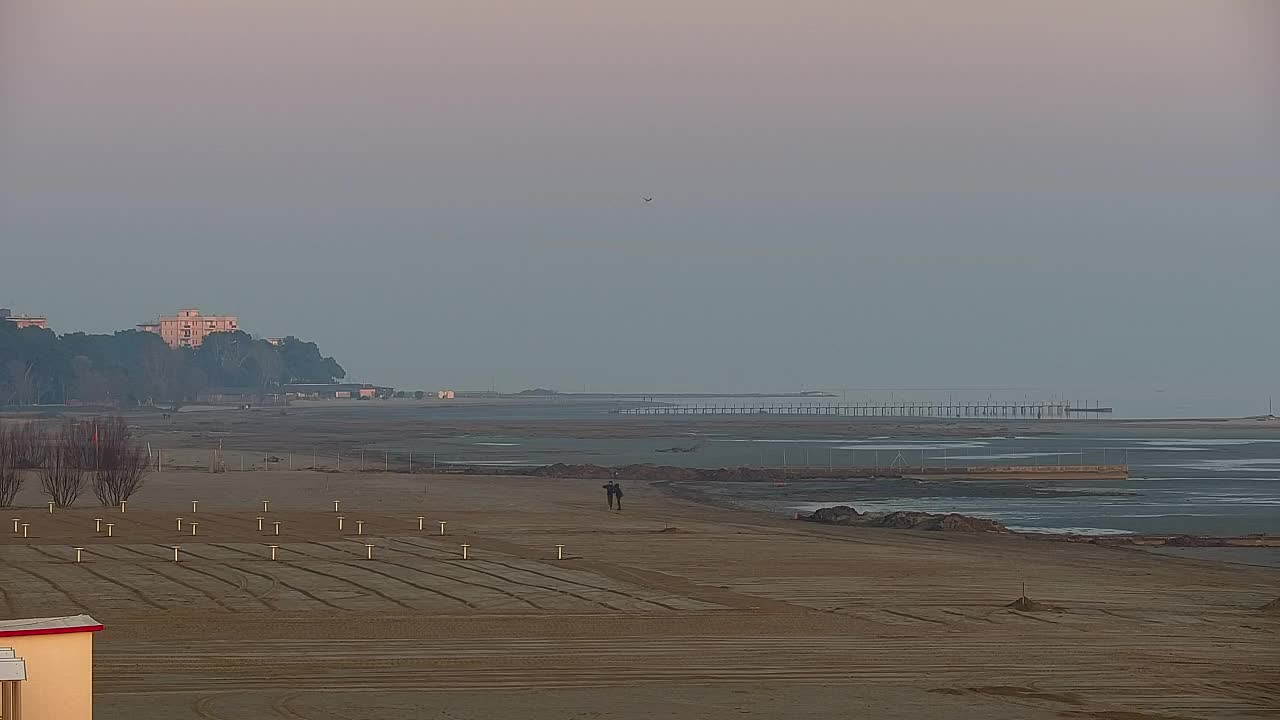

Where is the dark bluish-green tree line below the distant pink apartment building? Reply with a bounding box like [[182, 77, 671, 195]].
[[0, 322, 347, 406]]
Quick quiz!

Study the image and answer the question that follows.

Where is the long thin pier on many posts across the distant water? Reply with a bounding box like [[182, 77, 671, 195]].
[[612, 402, 1112, 420]]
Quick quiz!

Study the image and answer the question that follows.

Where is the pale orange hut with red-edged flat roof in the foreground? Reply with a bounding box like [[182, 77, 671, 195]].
[[0, 615, 102, 720]]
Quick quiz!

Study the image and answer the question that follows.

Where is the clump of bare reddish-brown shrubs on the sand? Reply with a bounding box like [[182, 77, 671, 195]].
[[0, 418, 151, 507]]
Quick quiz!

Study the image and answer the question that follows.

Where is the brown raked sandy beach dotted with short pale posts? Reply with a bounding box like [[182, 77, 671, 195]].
[[0, 471, 1280, 720]]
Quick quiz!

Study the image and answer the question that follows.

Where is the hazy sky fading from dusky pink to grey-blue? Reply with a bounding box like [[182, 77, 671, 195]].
[[0, 0, 1280, 411]]
